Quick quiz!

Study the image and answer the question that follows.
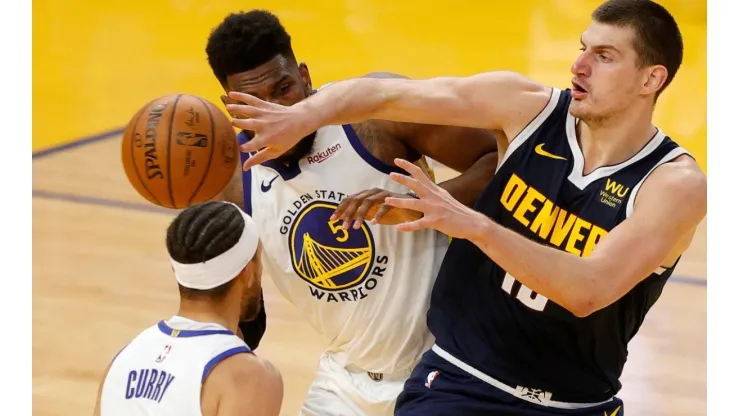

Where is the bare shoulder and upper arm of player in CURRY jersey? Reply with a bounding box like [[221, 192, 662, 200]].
[[201, 354, 283, 416]]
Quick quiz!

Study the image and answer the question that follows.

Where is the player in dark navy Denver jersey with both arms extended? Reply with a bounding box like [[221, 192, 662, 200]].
[[228, 0, 707, 416]]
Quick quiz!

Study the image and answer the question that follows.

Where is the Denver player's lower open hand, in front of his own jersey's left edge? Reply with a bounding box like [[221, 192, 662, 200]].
[[385, 159, 487, 239]]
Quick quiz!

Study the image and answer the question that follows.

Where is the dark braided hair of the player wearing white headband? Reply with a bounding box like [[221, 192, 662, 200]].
[[167, 201, 245, 300]]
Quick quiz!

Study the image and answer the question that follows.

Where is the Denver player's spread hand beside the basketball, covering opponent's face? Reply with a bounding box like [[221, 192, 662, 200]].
[[226, 91, 320, 170]]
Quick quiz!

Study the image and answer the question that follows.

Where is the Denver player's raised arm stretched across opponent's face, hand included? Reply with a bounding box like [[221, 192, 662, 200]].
[[227, 71, 552, 169]]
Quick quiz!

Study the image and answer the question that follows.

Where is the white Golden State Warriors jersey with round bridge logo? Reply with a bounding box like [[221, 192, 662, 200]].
[[239, 120, 448, 373]]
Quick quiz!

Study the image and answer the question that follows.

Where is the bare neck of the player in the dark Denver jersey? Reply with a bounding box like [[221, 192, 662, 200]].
[[576, 107, 657, 175]]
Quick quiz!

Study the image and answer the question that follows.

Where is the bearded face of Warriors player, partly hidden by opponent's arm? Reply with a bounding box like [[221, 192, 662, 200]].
[[222, 55, 315, 163]]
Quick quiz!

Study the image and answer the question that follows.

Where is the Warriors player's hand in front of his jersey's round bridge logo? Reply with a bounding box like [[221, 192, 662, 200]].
[[330, 188, 421, 229]]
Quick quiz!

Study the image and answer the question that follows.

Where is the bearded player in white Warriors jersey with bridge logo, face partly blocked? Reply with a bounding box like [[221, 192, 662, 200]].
[[206, 10, 497, 416]]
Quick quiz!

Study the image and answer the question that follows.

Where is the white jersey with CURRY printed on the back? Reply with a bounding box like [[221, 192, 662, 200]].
[[100, 316, 251, 416]]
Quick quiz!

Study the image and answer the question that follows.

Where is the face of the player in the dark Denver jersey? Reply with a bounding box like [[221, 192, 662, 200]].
[[570, 22, 646, 122]]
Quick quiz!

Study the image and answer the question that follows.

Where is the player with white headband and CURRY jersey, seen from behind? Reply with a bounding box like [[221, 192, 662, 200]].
[[95, 202, 283, 416]]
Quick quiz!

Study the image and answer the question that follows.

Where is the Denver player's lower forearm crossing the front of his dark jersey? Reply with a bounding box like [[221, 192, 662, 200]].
[[470, 220, 608, 316]]
